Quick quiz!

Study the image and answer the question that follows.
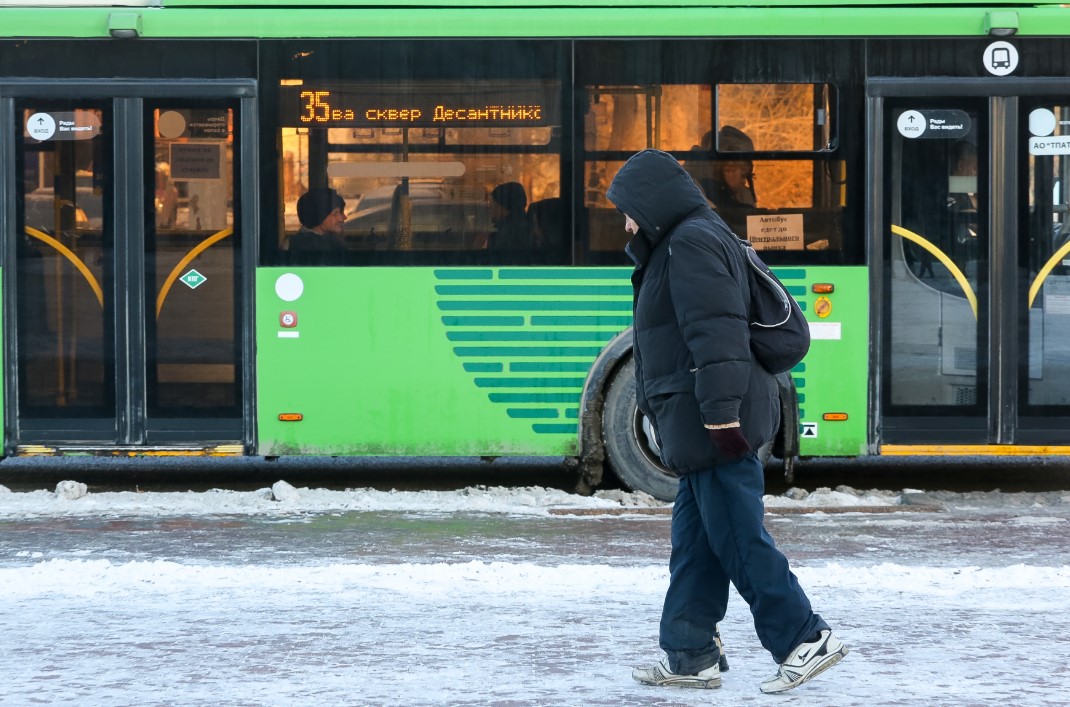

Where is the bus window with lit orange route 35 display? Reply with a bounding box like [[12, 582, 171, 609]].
[[279, 66, 570, 265]]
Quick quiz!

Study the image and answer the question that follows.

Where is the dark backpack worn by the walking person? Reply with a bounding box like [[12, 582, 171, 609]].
[[736, 237, 810, 374]]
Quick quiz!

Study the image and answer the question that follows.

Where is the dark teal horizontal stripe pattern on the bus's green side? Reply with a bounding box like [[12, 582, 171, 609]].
[[434, 267, 807, 435]]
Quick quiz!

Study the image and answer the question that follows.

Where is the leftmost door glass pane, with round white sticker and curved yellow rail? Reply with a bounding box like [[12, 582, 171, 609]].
[[16, 102, 116, 429]]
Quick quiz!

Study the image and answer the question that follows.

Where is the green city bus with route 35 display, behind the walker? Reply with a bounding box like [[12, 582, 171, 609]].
[[6, 0, 1070, 498]]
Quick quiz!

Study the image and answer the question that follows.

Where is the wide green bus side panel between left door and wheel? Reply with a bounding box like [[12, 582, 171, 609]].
[[257, 267, 631, 456]]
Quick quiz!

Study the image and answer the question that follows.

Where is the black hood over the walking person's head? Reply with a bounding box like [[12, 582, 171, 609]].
[[606, 150, 709, 245]]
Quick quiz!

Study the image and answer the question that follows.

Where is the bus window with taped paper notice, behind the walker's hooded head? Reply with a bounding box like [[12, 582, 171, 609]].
[[581, 78, 846, 264]]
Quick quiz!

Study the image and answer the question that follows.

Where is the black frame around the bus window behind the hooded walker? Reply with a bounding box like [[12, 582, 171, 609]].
[[575, 39, 867, 270]]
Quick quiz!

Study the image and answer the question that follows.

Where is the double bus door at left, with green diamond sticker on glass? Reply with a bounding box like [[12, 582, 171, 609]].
[[0, 84, 251, 454]]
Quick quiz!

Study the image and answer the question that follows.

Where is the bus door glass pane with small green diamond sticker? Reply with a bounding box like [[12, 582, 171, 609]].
[[144, 101, 242, 427]]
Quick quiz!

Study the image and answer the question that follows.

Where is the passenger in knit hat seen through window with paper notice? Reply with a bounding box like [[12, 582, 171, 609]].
[[686, 125, 759, 237]]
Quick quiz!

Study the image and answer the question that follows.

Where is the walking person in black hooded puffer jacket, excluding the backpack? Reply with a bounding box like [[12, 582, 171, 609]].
[[606, 150, 847, 693]]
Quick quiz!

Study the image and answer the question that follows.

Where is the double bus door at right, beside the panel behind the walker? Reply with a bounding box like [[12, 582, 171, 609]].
[[871, 86, 1070, 451]]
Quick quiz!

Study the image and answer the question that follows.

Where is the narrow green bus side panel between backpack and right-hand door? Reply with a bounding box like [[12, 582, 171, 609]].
[[796, 262, 869, 457]]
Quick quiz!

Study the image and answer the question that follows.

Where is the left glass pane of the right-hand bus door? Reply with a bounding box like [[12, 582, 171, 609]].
[[881, 98, 989, 443]]
